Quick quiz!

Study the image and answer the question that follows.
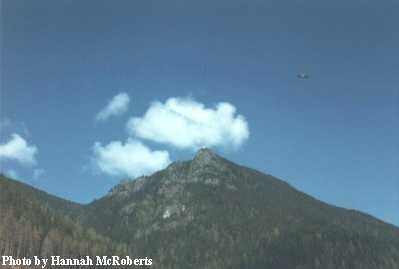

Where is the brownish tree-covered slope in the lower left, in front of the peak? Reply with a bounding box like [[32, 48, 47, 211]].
[[0, 175, 126, 257]]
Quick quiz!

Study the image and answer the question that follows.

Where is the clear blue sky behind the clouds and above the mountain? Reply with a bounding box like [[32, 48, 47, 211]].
[[0, 0, 399, 225]]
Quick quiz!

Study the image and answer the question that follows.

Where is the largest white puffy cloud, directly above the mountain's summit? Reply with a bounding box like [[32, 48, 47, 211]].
[[127, 98, 249, 149]]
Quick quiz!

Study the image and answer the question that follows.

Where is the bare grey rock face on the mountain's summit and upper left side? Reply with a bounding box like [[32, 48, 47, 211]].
[[98, 148, 238, 239]]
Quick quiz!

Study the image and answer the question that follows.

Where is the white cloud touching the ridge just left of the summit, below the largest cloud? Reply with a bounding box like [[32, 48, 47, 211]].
[[93, 139, 171, 177]]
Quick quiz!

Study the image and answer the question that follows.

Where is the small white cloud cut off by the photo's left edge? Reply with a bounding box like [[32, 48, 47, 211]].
[[0, 133, 38, 165]]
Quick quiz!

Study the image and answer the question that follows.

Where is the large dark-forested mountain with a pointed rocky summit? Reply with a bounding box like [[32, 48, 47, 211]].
[[0, 149, 399, 269]]
